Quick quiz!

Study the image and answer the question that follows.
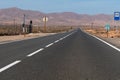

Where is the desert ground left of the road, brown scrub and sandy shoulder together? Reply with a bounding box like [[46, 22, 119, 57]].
[[0, 25, 72, 43]]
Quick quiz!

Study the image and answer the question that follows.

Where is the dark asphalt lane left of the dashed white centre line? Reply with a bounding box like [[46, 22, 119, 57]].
[[0, 32, 70, 68]]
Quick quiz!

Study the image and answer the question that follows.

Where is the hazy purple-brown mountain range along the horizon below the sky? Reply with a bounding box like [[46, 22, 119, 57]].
[[0, 7, 113, 25]]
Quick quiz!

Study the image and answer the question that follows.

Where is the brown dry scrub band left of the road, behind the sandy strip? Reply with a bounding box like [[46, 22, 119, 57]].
[[0, 25, 73, 36]]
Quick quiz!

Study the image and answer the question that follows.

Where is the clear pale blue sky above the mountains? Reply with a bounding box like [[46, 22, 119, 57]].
[[0, 0, 120, 14]]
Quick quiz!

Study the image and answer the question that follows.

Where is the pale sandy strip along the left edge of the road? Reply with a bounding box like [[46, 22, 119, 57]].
[[0, 33, 55, 43]]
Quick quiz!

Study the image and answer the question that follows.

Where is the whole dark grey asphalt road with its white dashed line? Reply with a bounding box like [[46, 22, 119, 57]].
[[0, 29, 120, 80]]
